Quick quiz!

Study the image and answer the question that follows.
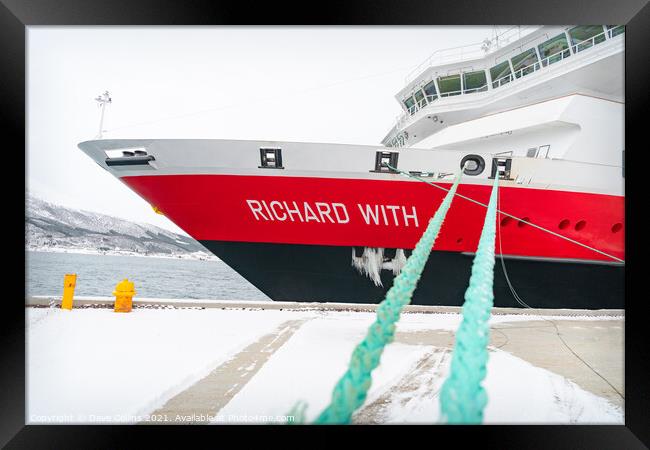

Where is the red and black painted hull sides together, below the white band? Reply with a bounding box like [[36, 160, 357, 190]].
[[116, 175, 624, 309]]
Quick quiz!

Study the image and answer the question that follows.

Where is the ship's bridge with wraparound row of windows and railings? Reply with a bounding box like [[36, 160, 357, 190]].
[[382, 25, 625, 147]]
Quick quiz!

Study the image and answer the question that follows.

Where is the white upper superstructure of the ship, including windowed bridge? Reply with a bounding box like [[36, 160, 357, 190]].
[[382, 25, 625, 188]]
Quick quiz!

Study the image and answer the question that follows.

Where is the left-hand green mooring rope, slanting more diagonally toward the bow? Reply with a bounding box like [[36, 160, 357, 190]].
[[306, 171, 462, 424]]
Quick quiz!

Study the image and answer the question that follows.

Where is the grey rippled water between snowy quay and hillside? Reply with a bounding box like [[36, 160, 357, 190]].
[[25, 252, 270, 300]]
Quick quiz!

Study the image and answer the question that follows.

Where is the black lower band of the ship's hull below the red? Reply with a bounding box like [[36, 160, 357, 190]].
[[201, 241, 625, 309]]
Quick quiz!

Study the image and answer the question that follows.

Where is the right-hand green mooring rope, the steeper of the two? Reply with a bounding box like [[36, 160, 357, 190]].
[[440, 176, 499, 424]]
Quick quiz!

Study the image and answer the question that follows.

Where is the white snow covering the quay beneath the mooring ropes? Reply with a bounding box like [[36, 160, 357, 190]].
[[26, 307, 624, 424]]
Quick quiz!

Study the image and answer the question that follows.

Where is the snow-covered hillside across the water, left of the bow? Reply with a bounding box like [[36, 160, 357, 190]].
[[25, 195, 214, 259]]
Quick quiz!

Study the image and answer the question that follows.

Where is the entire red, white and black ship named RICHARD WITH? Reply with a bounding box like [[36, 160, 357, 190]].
[[78, 25, 625, 309]]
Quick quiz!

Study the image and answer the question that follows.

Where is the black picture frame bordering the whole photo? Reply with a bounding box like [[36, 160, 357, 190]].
[[0, 0, 650, 449]]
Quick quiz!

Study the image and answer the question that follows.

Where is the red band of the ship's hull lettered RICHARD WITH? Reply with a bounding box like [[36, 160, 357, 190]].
[[122, 175, 625, 262]]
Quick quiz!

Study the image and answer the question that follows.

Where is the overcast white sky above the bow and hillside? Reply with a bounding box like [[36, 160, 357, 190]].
[[26, 26, 508, 232]]
